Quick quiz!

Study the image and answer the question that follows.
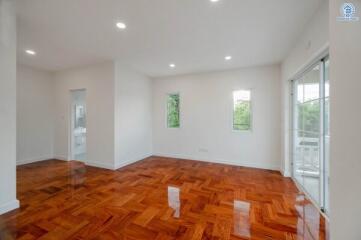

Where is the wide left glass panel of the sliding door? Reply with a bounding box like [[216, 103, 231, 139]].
[[293, 63, 322, 204]]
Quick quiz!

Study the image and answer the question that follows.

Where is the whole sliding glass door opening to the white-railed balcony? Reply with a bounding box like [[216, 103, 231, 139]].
[[293, 59, 329, 215]]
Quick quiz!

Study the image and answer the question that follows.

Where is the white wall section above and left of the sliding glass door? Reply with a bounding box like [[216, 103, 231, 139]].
[[281, 0, 329, 176]]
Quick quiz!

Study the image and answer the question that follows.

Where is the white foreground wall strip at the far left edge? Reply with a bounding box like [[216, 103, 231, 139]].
[[0, 0, 19, 214]]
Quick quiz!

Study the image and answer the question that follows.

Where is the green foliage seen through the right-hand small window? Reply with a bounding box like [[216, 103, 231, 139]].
[[233, 101, 251, 130]]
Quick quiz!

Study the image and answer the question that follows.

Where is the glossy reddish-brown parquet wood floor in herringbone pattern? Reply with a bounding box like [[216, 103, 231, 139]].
[[0, 157, 326, 240]]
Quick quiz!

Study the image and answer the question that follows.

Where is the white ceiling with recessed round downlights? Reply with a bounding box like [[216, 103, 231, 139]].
[[17, 0, 322, 77]]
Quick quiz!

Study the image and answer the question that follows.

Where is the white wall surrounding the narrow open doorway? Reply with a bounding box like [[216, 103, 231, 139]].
[[54, 62, 114, 169]]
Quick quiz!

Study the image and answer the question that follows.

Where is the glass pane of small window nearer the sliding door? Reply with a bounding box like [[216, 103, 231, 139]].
[[233, 90, 251, 130]]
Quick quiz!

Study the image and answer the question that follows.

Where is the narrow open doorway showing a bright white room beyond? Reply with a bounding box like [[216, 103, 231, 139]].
[[70, 89, 87, 161]]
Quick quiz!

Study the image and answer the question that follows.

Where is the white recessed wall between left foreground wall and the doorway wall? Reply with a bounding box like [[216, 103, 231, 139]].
[[17, 65, 55, 164]]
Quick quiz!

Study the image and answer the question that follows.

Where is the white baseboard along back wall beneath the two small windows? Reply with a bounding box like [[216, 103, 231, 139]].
[[154, 153, 281, 172]]
